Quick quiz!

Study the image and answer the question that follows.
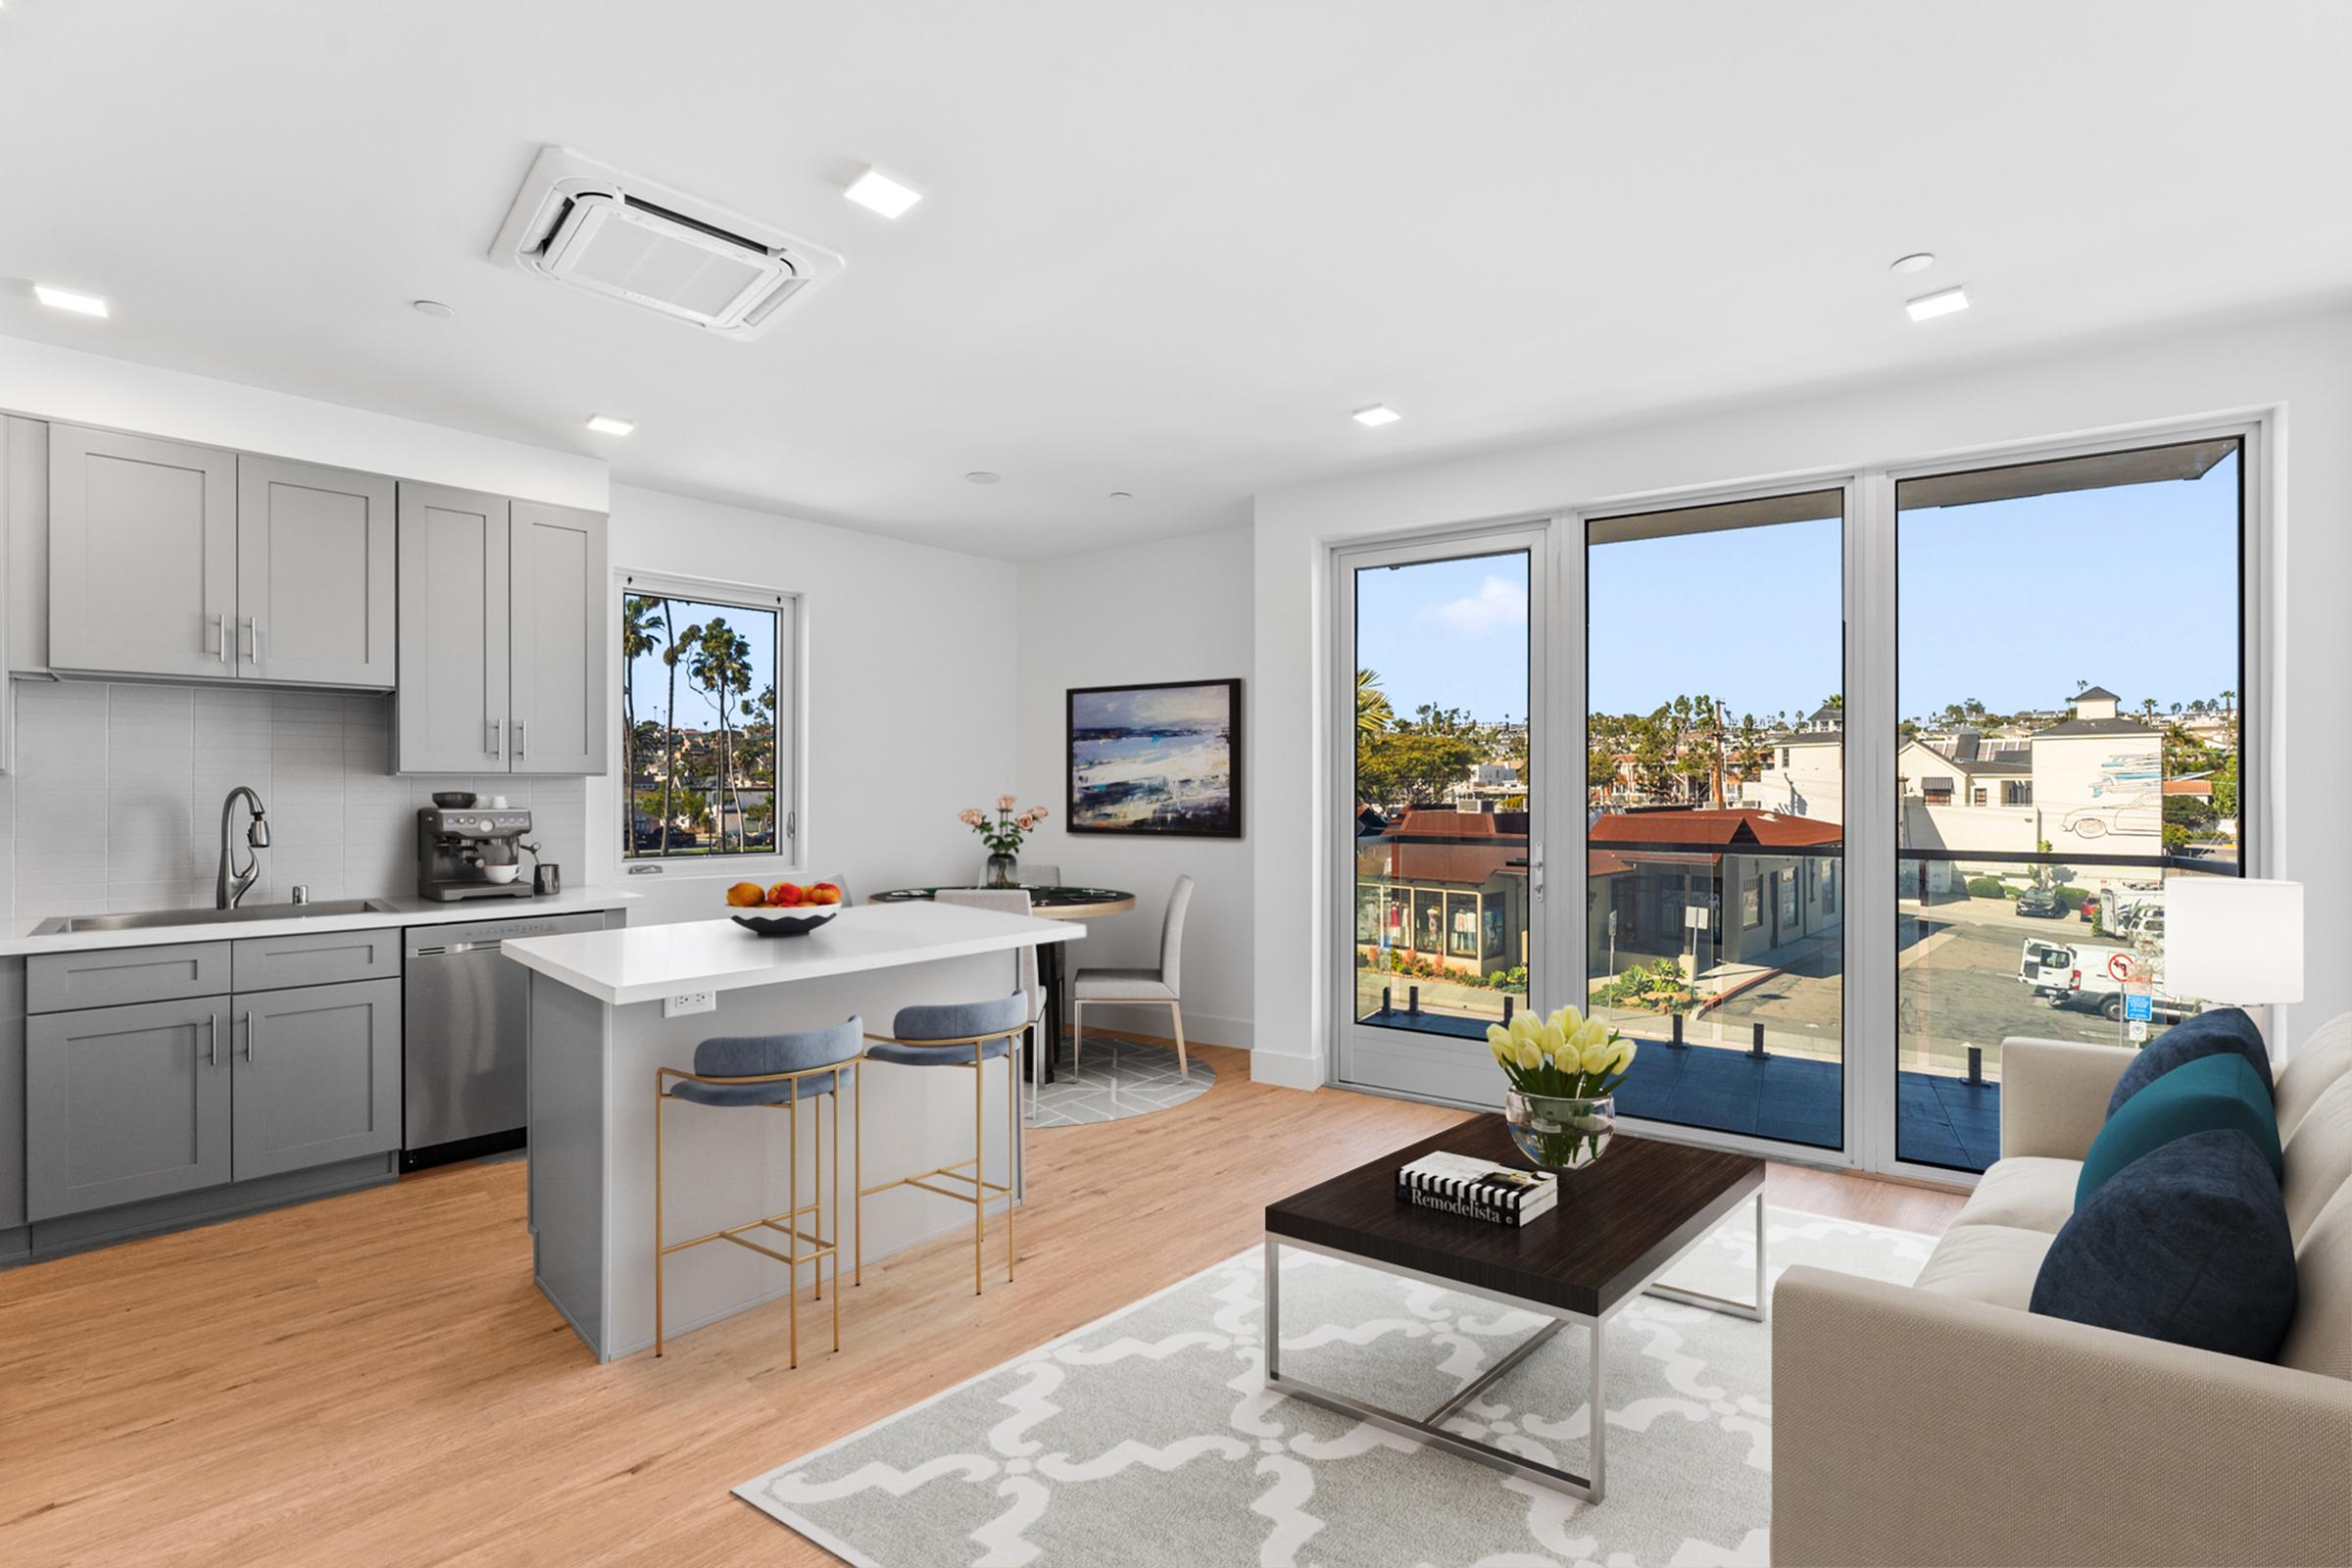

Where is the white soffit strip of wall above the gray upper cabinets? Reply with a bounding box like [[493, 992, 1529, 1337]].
[[0, 338, 605, 513]]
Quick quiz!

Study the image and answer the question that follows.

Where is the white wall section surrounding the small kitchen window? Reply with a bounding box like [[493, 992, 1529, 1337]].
[[588, 484, 1018, 924]]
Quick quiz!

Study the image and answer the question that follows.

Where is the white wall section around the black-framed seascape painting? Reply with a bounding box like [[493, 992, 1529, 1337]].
[[1020, 529, 1258, 1049]]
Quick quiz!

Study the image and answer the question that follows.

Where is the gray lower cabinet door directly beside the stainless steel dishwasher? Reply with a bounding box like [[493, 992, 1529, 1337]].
[[230, 980, 400, 1183]]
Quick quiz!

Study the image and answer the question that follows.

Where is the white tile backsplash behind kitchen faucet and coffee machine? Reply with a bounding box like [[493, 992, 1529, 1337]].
[[0, 679, 588, 919]]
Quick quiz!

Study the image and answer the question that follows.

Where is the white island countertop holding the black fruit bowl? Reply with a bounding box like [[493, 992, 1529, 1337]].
[[504, 903, 1087, 1006]]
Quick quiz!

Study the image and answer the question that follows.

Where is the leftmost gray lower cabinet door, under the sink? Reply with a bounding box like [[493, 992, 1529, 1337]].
[[24, 997, 233, 1220]]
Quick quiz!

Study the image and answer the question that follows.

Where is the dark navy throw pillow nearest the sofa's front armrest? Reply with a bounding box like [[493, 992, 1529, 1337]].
[[2033, 1128, 2295, 1361]]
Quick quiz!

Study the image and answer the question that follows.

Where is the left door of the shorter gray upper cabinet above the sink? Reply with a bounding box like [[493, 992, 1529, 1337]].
[[49, 423, 237, 679]]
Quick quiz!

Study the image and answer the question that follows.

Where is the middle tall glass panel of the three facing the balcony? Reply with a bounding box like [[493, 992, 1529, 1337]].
[[1583, 489, 1846, 1150]]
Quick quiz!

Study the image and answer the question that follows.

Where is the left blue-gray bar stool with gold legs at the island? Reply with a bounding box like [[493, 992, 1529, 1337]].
[[654, 1018, 865, 1368]]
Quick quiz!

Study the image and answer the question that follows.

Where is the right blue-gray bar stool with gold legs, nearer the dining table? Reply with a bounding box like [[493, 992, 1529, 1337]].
[[856, 992, 1028, 1296]]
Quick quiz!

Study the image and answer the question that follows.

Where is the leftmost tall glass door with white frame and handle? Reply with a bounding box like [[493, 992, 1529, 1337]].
[[1336, 529, 1547, 1102]]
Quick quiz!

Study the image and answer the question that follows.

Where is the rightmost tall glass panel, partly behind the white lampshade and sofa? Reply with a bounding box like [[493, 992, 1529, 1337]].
[[1893, 437, 2244, 1171]]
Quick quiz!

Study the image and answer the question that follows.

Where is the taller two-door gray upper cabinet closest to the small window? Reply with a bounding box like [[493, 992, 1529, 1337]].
[[393, 482, 610, 773]]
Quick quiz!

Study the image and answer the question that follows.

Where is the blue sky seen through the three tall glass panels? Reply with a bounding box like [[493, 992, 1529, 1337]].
[[1357, 456, 2239, 719]]
